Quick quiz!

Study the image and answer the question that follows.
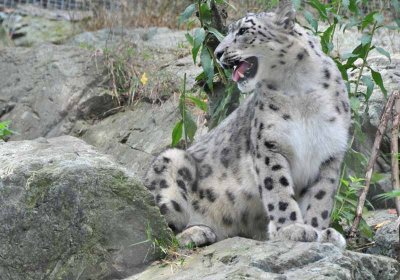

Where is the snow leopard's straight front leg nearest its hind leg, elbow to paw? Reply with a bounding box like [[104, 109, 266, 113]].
[[254, 147, 319, 242]]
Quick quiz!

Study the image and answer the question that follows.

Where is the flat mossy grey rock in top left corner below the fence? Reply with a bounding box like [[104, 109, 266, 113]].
[[3, 13, 81, 47]]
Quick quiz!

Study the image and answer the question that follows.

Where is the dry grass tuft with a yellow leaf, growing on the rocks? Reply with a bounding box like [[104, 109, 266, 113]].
[[101, 42, 189, 107]]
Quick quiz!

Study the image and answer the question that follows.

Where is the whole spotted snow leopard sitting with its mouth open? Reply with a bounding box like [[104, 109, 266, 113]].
[[146, 1, 350, 247]]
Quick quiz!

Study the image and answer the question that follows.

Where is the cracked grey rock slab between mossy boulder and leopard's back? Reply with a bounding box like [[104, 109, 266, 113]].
[[73, 98, 179, 177]]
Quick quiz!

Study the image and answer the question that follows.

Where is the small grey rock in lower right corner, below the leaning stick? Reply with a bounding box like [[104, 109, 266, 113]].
[[366, 209, 400, 261]]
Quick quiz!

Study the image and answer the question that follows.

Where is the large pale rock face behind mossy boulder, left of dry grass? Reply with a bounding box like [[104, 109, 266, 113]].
[[0, 45, 116, 140]]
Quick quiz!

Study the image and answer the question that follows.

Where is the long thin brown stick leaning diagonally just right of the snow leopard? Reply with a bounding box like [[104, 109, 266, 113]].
[[349, 92, 399, 239]]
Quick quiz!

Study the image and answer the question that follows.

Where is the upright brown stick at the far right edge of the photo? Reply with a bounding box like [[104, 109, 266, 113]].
[[391, 92, 400, 216]]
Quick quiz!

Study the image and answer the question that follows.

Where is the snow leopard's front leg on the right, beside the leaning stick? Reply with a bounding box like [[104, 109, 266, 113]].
[[299, 155, 346, 248]]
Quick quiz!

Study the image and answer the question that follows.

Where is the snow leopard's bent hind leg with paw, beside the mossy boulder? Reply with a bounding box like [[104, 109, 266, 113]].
[[145, 149, 217, 246]]
